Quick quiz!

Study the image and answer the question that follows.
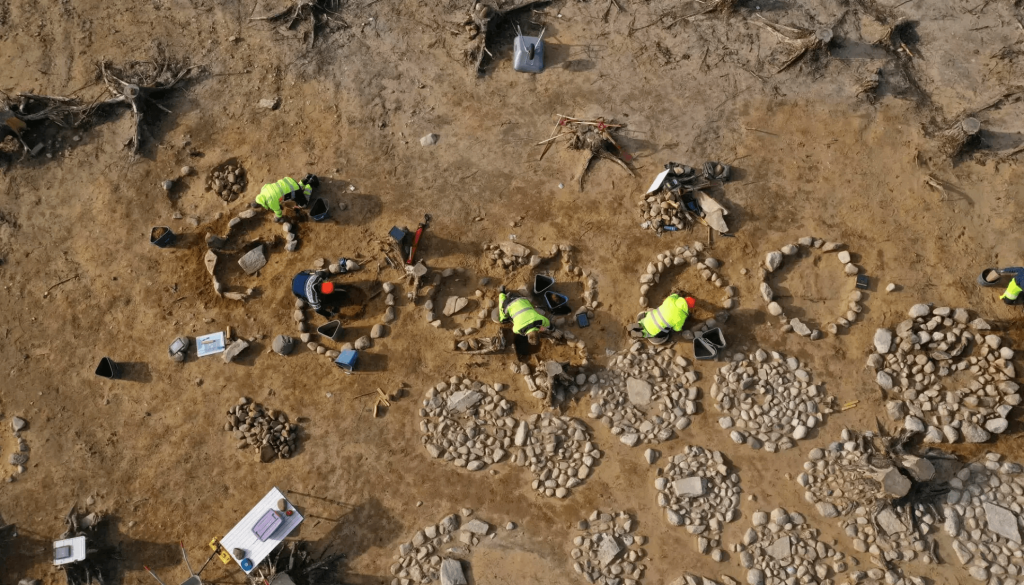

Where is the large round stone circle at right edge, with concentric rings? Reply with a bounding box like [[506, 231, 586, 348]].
[[867, 304, 1021, 443]]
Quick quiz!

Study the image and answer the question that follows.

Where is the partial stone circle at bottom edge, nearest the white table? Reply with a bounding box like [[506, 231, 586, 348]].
[[390, 509, 495, 585]]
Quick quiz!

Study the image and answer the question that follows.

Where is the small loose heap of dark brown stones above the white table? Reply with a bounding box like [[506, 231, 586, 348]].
[[224, 396, 299, 463]]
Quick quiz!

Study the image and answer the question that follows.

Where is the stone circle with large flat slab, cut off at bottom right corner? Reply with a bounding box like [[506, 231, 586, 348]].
[[944, 453, 1024, 584]]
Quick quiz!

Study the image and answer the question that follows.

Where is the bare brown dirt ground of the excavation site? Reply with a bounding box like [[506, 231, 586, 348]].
[[0, 0, 1024, 585]]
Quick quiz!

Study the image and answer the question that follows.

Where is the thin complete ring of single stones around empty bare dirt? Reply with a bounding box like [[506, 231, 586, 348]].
[[761, 236, 863, 340]]
